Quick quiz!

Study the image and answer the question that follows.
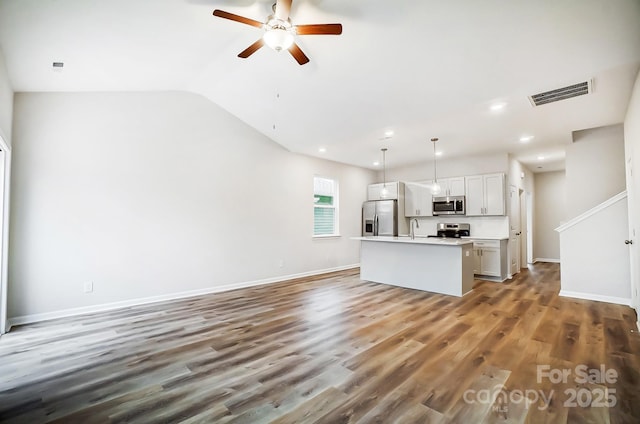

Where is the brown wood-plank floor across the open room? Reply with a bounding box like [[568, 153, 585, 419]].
[[0, 264, 640, 423]]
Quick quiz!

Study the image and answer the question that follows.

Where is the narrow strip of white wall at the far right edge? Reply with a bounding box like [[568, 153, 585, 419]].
[[624, 68, 640, 314]]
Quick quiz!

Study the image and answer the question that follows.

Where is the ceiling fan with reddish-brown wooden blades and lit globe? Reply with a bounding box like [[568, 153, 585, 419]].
[[213, 0, 342, 65]]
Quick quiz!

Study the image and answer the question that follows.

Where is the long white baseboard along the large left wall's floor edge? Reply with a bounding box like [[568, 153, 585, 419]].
[[7, 263, 360, 332]]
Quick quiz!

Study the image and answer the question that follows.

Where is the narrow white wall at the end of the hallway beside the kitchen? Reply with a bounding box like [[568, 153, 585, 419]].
[[533, 171, 566, 261]]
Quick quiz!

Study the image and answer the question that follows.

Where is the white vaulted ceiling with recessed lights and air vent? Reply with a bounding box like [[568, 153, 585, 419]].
[[0, 0, 640, 171]]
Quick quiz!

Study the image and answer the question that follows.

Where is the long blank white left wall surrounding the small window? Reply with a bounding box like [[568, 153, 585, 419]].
[[9, 92, 375, 320]]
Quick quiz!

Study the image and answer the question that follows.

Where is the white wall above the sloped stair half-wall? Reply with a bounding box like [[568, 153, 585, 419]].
[[566, 125, 625, 219]]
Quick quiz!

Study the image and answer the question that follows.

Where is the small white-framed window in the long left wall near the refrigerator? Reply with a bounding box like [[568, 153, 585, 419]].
[[313, 177, 338, 236]]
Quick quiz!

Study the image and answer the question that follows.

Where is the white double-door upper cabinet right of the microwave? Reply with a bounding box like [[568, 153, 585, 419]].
[[465, 173, 505, 216]]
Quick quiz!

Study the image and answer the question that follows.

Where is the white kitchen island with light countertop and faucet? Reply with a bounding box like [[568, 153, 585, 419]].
[[353, 236, 473, 296]]
